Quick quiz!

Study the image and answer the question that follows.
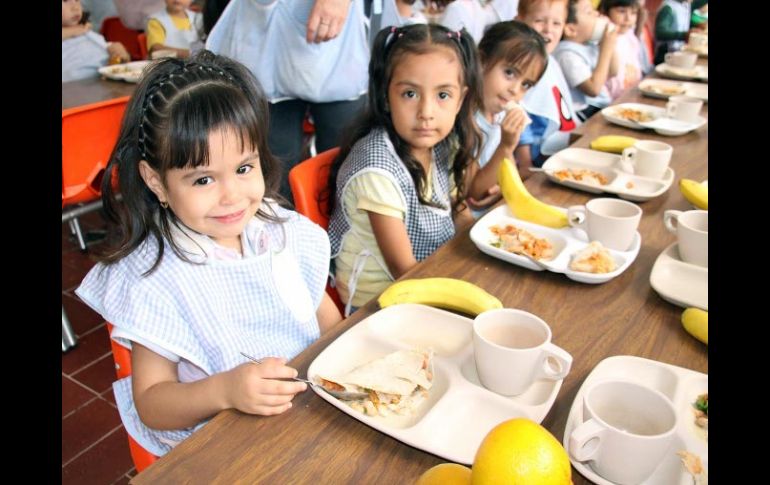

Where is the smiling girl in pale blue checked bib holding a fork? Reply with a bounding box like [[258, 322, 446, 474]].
[[76, 51, 340, 455]]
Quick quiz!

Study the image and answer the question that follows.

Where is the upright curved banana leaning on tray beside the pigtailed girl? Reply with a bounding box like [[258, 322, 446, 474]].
[[497, 158, 569, 229]]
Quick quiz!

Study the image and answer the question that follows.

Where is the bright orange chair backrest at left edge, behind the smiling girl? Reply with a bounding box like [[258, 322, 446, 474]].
[[61, 96, 129, 207]]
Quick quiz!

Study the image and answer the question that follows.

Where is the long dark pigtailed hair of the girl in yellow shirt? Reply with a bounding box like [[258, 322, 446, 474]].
[[326, 24, 481, 212]]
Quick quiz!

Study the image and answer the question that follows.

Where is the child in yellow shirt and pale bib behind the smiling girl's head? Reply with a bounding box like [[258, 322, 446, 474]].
[[146, 0, 203, 57]]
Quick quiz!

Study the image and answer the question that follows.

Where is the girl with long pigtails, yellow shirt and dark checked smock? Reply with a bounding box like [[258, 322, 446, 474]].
[[329, 24, 479, 313]]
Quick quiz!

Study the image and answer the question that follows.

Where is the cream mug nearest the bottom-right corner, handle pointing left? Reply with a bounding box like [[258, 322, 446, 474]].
[[569, 380, 676, 485]]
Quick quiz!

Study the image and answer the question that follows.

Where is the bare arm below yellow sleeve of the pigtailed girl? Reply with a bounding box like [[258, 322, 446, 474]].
[[367, 211, 417, 279]]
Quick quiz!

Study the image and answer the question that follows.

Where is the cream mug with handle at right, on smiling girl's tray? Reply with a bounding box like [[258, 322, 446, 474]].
[[473, 308, 572, 396]]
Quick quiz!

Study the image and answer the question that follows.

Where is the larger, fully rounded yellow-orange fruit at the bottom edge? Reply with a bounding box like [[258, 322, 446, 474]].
[[471, 418, 572, 485]]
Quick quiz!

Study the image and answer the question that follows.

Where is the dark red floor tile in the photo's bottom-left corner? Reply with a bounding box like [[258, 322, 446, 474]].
[[61, 426, 134, 485]]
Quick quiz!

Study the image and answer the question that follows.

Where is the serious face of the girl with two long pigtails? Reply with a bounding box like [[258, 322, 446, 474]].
[[388, 47, 468, 159]]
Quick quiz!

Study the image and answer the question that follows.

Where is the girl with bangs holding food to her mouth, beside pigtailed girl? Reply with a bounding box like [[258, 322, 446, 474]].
[[469, 20, 548, 206]]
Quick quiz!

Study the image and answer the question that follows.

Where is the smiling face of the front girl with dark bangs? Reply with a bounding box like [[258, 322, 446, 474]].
[[142, 126, 265, 251]]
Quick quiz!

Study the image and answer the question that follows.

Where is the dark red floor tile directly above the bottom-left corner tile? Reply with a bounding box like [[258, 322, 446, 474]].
[[61, 399, 121, 466]]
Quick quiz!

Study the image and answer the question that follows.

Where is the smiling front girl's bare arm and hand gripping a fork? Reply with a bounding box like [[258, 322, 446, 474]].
[[131, 343, 307, 429]]
